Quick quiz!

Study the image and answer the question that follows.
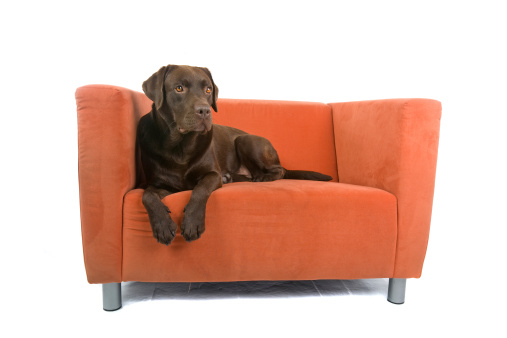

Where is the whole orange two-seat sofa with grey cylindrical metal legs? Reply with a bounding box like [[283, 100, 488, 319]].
[[76, 85, 441, 310]]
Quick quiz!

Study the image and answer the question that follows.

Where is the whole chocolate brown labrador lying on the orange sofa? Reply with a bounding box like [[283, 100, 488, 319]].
[[137, 65, 331, 245]]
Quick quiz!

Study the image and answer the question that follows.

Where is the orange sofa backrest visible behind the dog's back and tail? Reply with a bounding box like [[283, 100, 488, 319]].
[[213, 99, 338, 181]]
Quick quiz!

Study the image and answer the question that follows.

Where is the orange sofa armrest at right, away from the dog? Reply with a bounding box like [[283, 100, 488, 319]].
[[330, 99, 442, 278]]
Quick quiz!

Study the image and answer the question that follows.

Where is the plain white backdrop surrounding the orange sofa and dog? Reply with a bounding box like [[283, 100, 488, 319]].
[[0, 0, 507, 336]]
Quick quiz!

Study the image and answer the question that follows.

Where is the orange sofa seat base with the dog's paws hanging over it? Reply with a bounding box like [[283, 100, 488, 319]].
[[122, 180, 397, 282]]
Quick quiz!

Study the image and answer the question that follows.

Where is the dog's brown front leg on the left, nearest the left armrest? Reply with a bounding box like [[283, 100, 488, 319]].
[[143, 186, 178, 245]]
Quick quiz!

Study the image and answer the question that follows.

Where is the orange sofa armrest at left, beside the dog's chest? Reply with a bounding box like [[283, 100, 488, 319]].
[[76, 85, 151, 283]]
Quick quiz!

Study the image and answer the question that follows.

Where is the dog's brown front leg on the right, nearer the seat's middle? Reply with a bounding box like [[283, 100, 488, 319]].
[[181, 172, 222, 242]]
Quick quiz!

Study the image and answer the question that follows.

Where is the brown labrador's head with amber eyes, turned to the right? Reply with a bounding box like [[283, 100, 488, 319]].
[[143, 65, 218, 134]]
